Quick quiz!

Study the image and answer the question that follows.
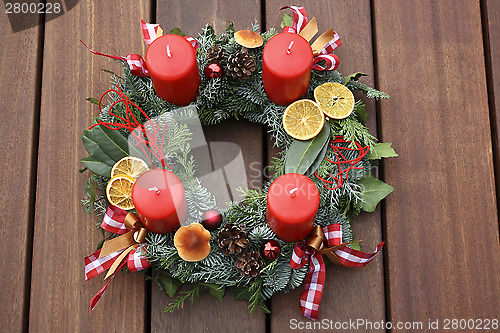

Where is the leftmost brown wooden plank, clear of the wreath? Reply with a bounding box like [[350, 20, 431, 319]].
[[0, 7, 41, 332]]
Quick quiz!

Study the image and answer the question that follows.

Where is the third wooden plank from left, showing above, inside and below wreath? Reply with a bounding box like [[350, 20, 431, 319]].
[[151, 0, 265, 332]]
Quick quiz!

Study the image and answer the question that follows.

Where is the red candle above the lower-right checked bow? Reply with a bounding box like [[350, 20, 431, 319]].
[[266, 173, 319, 243]]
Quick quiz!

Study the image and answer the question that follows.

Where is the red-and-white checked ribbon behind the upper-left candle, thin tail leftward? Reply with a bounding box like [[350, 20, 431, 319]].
[[80, 19, 199, 77]]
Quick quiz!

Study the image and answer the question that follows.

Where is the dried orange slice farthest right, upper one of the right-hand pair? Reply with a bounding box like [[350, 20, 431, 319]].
[[314, 82, 354, 119]]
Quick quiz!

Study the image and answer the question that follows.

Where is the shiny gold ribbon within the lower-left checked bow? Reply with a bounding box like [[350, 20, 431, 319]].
[[99, 213, 148, 279]]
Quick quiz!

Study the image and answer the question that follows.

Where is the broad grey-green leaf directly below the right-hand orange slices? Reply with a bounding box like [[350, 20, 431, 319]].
[[285, 122, 330, 174]]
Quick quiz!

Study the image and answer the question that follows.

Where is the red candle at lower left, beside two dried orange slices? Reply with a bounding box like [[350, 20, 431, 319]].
[[132, 169, 187, 234]]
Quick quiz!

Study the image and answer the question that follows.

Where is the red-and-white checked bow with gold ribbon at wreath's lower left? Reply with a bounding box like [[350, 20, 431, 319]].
[[85, 205, 151, 312]]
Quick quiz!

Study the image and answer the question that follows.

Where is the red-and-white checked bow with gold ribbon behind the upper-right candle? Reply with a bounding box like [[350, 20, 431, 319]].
[[281, 6, 342, 71]]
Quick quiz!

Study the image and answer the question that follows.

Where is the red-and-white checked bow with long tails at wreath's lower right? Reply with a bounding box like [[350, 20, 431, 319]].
[[290, 223, 384, 321]]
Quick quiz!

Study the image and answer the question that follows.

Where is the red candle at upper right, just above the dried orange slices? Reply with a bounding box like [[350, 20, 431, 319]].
[[262, 32, 313, 105]]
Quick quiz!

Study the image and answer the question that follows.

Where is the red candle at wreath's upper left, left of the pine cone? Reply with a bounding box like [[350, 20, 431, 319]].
[[146, 35, 200, 105]]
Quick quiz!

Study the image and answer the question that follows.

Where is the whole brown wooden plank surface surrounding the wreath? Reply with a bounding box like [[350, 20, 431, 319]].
[[0, 0, 500, 332]]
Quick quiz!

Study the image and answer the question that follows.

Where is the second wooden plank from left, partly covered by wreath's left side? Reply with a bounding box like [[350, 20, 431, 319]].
[[29, 0, 150, 332]]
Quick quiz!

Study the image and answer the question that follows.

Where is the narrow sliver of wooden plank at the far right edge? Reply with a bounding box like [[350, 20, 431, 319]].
[[481, 0, 500, 206]]
